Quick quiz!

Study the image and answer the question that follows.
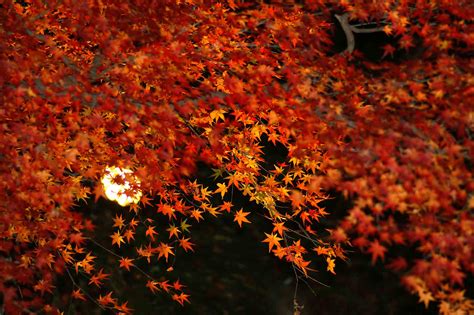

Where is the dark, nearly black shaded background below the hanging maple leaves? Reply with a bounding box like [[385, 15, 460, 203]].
[[56, 188, 437, 315]]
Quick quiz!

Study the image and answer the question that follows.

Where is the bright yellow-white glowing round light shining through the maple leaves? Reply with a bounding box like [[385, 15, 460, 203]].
[[101, 166, 142, 207]]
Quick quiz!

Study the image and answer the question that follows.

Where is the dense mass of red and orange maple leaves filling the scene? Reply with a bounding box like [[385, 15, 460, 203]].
[[0, 0, 474, 314]]
